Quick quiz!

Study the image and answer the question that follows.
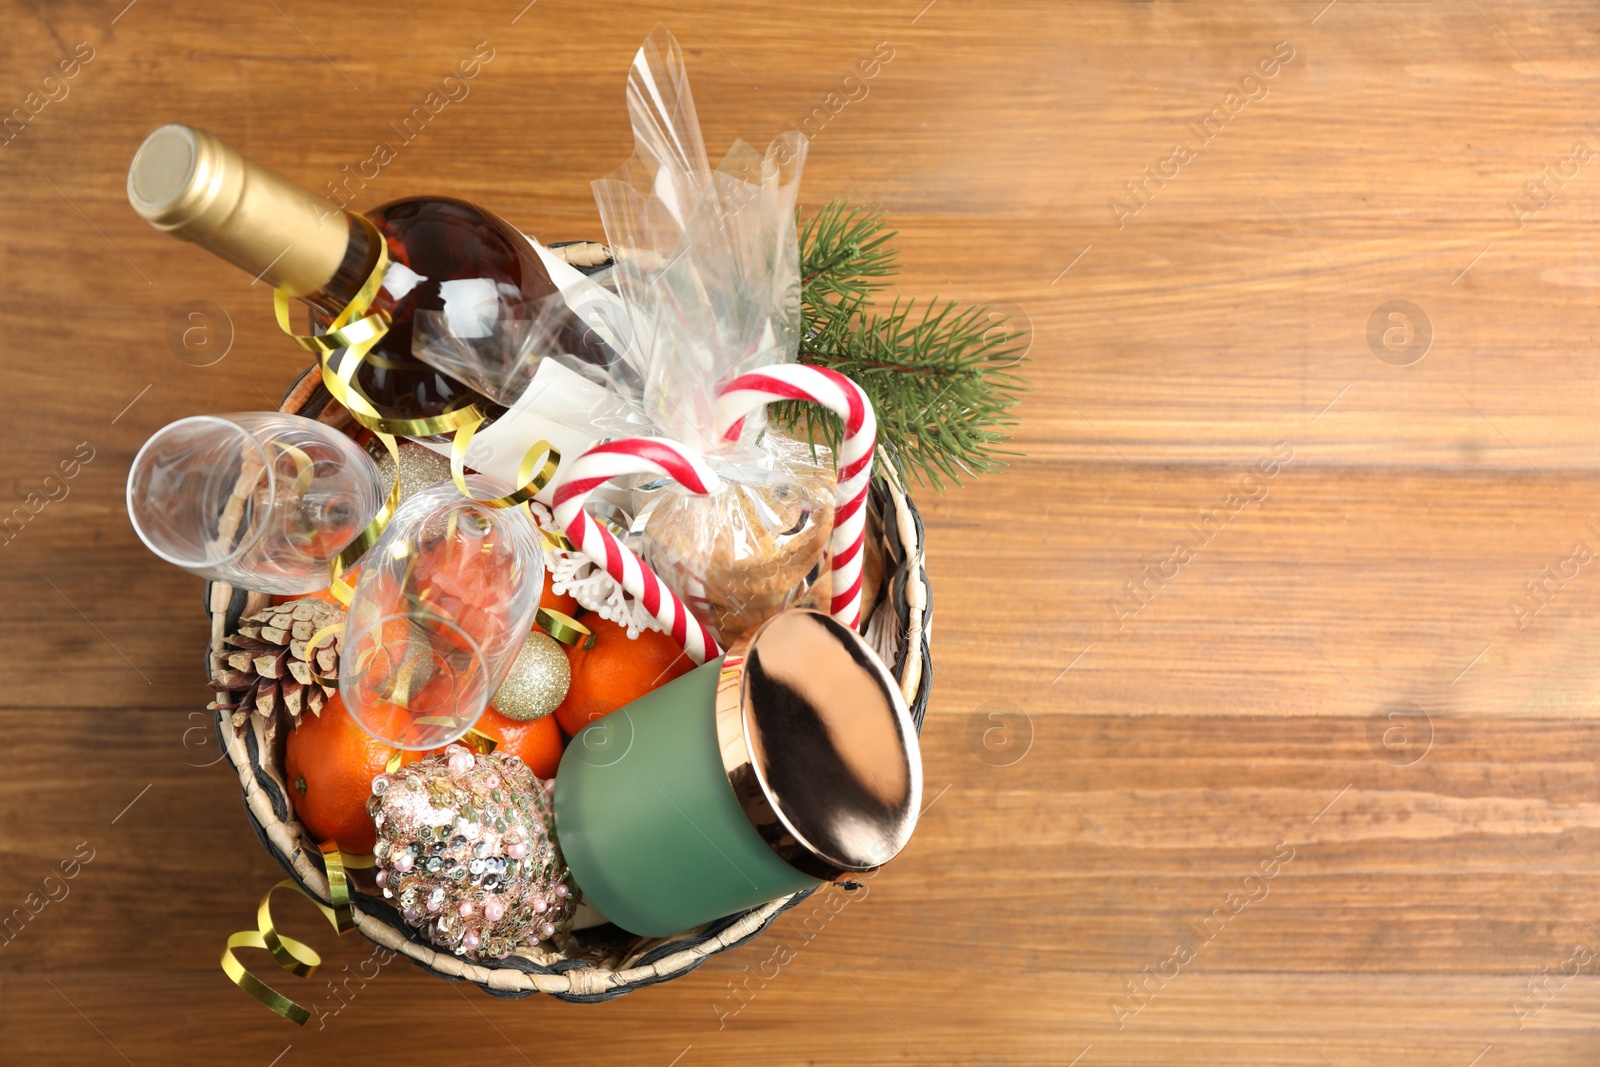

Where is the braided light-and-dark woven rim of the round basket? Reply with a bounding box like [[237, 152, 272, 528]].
[[205, 252, 933, 1001]]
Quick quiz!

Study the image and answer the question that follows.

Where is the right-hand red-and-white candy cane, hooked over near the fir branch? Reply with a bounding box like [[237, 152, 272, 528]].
[[717, 363, 878, 629]]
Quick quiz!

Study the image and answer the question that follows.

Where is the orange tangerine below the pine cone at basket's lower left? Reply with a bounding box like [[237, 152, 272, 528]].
[[283, 693, 422, 856]]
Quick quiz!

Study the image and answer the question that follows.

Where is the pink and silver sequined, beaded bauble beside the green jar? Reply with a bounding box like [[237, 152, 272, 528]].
[[366, 745, 576, 960]]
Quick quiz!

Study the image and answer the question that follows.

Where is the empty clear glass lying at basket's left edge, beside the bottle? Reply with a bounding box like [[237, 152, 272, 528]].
[[128, 411, 386, 595]]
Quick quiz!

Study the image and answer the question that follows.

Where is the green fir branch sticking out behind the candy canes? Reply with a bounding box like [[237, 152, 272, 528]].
[[793, 200, 1027, 490]]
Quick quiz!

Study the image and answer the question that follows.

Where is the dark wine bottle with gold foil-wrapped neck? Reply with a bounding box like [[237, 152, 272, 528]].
[[128, 125, 605, 419]]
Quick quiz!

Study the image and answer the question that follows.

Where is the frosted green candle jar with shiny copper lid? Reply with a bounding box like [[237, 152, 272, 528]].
[[555, 611, 922, 937]]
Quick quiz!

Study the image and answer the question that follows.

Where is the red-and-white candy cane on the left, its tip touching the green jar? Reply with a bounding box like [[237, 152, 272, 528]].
[[552, 437, 722, 664]]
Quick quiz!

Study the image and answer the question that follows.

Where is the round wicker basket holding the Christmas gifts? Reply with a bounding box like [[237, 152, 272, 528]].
[[205, 255, 933, 1003]]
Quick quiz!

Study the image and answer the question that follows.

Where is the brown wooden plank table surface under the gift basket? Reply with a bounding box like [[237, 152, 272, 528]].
[[0, 0, 1600, 1067]]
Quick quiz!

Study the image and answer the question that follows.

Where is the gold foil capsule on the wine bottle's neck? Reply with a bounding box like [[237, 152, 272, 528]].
[[128, 125, 350, 296]]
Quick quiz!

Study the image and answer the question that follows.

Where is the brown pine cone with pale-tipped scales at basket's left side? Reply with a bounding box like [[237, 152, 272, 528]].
[[210, 597, 344, 741]]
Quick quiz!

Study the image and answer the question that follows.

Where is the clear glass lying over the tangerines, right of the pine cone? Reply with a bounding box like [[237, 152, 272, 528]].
[[339, 475, 544, 750]]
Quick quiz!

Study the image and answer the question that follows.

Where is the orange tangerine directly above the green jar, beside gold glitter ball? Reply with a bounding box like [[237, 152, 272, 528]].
[[555, 614, 694, 736]]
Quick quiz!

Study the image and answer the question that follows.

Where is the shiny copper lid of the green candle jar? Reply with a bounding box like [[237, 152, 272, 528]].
[[717, 609, 922, 880]]
